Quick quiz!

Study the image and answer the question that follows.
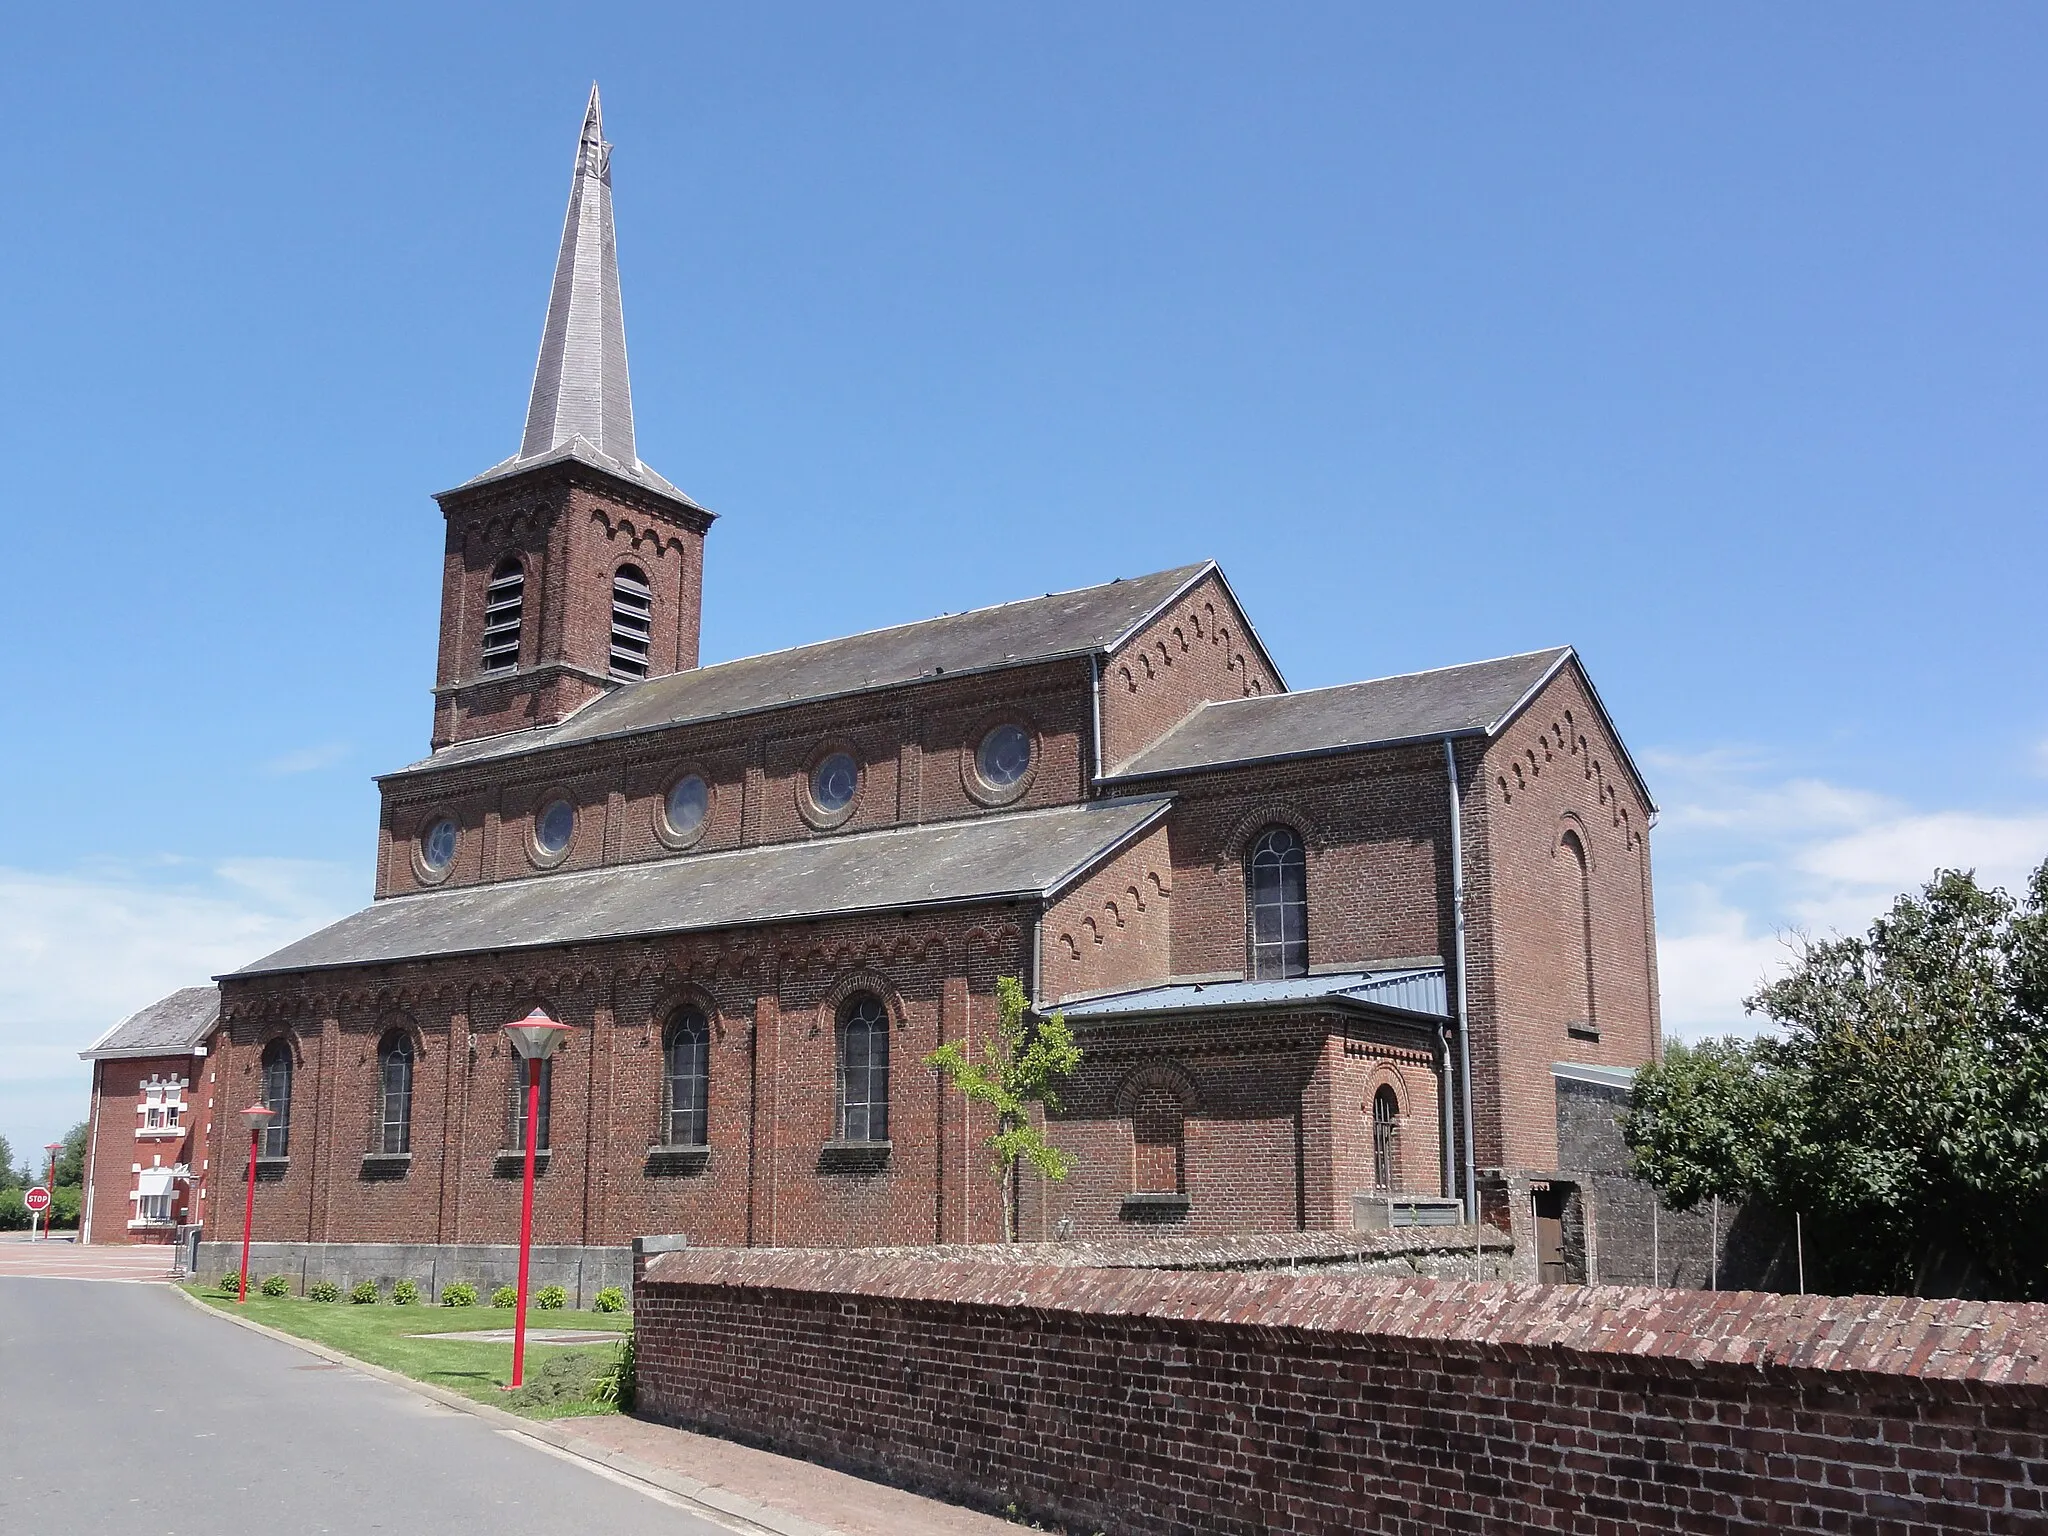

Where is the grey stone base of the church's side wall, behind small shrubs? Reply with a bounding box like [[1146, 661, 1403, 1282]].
[[199, 1243, 633, 1307]]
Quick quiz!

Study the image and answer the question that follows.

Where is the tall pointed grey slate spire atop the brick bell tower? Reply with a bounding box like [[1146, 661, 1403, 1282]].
[[456, 84, 696, 506]]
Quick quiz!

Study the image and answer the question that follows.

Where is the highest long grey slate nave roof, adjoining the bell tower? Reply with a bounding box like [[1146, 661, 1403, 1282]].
[[385, 561, 1217, 778]]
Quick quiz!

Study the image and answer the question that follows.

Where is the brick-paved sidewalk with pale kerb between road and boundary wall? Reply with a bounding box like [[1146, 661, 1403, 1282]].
[[180, 1286, 1028, 1536]]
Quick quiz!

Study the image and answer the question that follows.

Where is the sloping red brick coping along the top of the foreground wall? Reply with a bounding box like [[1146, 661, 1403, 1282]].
[[647, 1249, 2048, 1389]]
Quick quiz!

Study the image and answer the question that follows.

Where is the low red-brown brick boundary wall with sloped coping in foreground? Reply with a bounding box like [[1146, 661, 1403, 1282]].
[[635, 1249, 2048, 1536]]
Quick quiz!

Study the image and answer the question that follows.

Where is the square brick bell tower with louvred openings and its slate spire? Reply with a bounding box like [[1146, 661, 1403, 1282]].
[[434, 86, 715, 752]]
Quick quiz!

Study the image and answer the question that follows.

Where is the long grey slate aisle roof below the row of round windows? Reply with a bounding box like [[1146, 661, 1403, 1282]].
[[233, 797, 1169, 977]]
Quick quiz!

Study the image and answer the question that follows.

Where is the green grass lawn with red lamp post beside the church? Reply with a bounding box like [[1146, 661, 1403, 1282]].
[[186, 1276, 633, 1419]]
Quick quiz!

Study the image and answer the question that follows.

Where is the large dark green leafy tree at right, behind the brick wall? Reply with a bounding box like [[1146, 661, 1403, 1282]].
[[1622, 864, 2048, 1300]]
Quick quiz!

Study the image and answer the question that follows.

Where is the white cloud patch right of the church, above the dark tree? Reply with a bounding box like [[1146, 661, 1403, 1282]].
[[1649, 750, 2048, 1038]]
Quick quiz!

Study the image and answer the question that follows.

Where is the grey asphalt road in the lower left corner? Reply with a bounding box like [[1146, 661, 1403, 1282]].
[[0, 1278, 729, 1536]]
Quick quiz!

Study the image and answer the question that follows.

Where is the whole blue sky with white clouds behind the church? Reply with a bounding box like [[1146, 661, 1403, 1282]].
[[0, 2, 2048, 1149]]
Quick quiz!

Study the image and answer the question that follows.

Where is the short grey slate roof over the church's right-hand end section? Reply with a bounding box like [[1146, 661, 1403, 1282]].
[[1110, 645, 1573, 780]]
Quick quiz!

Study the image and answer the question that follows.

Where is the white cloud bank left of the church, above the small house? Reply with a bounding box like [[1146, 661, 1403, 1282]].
[[0, 858, 367, 1149]]
